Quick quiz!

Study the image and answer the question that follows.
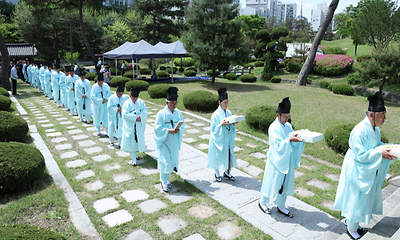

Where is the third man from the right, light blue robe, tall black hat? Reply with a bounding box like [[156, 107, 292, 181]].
[[207, 88, 237, 182]]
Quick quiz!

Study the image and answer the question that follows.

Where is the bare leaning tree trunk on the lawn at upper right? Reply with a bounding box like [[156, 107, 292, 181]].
[[296, 0, 339, 86]]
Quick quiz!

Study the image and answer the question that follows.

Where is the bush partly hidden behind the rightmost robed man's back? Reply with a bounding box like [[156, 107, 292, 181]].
[[324, 124, 355, 153]]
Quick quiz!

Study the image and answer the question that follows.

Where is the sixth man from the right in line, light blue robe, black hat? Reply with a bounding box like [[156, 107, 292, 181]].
[[107, 82, 129, 148]]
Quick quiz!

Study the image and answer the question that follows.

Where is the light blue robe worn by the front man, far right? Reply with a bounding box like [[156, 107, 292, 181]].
[[334, 117, 393, 225]]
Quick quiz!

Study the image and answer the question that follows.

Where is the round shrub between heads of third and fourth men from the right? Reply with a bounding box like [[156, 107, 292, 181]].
[[183, 91, 218, 112]]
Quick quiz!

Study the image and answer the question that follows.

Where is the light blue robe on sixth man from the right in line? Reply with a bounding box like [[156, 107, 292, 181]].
[[107, 93, 129, 139]]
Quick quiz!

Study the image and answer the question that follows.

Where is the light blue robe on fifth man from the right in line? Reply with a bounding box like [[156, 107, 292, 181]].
[[121, 98, 147, 152]]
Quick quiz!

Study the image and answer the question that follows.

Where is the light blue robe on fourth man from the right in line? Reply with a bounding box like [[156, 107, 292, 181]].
[[154, 106, 185, 174]]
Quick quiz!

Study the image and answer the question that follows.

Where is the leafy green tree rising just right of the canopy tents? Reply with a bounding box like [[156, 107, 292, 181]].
[[183, 0, 249, 83]]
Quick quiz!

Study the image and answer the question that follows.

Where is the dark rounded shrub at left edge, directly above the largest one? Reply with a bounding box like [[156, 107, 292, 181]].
[[0, 111, 29, 142]]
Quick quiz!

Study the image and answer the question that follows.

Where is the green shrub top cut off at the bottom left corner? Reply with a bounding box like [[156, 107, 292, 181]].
[[0, 224, 68, 240]]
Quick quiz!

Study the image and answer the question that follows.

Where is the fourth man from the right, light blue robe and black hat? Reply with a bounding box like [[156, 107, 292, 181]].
[[154, 87, 185, 192]]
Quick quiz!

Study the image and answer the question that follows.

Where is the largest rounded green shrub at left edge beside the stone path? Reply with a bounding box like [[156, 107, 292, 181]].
[[0, 142, 46, 192]]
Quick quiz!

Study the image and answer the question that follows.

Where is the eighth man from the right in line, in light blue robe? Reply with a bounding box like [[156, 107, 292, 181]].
[[75, 69, 92, 124]]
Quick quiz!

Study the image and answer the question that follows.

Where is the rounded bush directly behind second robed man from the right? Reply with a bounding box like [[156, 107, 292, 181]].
[[246, 105, 276, 133]]
